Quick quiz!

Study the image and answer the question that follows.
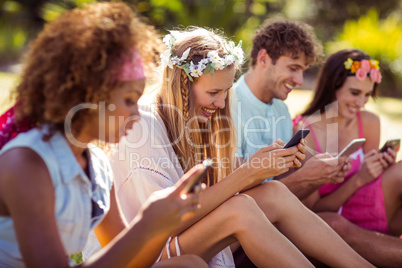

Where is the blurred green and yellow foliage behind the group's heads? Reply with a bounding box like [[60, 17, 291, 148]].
[[0, 0, 402, 97]]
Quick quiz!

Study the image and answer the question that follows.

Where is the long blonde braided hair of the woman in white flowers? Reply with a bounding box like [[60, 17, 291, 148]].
[[157, 27, 236, 185]]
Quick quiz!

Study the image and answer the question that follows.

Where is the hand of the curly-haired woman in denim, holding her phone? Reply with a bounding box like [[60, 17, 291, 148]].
[[140, 165, 205, 237]]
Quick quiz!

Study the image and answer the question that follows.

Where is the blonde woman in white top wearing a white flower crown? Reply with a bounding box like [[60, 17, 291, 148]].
[[111, 27, 370, 267]]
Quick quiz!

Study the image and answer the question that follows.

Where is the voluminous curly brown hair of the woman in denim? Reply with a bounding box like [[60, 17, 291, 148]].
[[15, 3, 161, 136]]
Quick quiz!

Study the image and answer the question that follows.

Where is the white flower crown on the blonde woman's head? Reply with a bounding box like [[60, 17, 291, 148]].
[[161, 31, 244, 82]]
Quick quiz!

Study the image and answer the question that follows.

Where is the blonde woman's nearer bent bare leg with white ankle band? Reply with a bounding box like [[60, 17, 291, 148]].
[[164, 195, 312, 267]]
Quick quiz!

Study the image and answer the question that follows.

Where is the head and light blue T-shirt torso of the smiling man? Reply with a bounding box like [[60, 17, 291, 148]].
[[233, 20, 322, 165]]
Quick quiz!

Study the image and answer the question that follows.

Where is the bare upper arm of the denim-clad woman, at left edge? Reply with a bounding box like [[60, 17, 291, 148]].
[[0, 148, 73, 267]]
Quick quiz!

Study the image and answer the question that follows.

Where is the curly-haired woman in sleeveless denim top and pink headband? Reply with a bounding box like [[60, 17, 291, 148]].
[[0, 3, 206, 267]]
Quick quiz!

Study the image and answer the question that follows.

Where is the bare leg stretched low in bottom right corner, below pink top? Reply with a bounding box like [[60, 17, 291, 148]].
[[318, 212, 402, 267]]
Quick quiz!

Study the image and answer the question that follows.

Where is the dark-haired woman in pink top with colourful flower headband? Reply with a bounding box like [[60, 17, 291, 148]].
[[295, 50, 402, 236]]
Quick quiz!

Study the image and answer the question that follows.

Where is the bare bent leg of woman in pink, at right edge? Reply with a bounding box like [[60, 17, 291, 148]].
[[381, 161, 402, 236]]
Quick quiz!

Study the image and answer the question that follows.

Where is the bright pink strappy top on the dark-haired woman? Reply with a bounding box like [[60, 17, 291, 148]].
[[293, 113, 388, 233]]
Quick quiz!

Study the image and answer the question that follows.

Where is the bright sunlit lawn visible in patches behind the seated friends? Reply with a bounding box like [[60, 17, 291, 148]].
[[0, 72, 402, 160]]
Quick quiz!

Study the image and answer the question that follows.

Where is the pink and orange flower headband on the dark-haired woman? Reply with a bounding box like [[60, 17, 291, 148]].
[[344, 58, 382, 84]]
